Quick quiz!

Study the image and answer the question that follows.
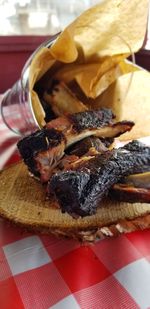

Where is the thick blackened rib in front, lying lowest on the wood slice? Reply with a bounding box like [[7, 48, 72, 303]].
[[49, 141, 150, 216]]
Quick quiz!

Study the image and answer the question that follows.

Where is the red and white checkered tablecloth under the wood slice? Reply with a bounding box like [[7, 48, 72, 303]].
[[0, 97, 150, 309]]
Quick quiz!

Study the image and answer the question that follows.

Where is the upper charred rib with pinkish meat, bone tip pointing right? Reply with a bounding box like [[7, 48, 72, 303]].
[[18, 109, 134, 182]]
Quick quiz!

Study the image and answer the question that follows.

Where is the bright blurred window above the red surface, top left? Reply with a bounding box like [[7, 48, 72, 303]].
[[0, 0, 100, 35]]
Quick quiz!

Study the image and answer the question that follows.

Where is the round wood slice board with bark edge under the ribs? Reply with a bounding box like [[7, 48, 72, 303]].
[[0, 162, 150, 241]]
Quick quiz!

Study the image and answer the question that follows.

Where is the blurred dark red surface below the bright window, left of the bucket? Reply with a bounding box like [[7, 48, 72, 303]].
[[0, 36, 50, 93]]
